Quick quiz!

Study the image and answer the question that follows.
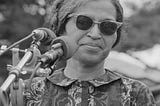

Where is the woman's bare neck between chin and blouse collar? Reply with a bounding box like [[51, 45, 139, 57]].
[[64, 59, 105, 80]]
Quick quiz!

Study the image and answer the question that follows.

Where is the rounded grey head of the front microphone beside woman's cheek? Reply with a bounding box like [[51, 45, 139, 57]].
[[52, 36, 79, 60]]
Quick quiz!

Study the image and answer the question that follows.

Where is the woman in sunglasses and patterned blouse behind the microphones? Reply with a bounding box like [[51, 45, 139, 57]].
[[24, 0, 155, 106]]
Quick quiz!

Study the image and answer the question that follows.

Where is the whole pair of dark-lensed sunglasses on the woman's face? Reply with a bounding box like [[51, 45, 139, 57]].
[[69, 14, 122, 36]]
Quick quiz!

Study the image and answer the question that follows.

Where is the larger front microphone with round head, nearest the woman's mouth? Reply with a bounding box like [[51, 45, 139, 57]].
[[40, 36, 78, 66]]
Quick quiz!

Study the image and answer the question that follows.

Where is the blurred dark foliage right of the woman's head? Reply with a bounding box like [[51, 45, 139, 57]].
[[121, 2, 160, 51]]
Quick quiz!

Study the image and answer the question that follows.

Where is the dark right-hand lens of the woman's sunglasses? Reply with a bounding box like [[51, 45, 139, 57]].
[[100, 22, 117, 35]]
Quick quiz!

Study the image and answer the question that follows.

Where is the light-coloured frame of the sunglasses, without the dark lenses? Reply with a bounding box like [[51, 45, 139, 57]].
[[68, 14, 123, 35]]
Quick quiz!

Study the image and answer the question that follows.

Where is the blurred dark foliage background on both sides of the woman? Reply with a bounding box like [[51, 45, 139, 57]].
[[0, 0, 160, 104]]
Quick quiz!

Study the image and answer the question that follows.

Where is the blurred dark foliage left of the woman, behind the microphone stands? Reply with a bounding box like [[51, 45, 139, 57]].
[[0, 0, 45, 83]]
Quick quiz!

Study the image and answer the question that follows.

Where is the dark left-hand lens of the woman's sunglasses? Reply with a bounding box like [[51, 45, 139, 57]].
[[76, 15, 93, 30]]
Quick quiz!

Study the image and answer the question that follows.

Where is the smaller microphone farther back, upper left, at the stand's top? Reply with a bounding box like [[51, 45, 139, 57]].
[[32, 28, 56, 46]]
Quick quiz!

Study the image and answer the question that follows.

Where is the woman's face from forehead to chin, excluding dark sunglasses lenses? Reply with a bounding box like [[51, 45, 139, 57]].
[[65, 0, 117, 65]]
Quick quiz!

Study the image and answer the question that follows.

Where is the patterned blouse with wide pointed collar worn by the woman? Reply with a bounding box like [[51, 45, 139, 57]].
[[24, 69, 156, 106]]
